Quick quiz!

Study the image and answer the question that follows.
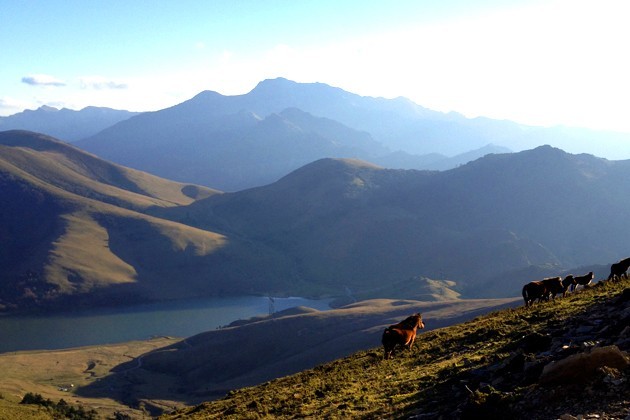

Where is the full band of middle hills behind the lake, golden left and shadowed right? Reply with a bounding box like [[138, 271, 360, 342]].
[[0, 131, 630, 310]]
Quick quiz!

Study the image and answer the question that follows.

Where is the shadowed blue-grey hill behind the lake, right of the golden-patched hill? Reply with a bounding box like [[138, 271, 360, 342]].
[[156, 146, 630, 297]]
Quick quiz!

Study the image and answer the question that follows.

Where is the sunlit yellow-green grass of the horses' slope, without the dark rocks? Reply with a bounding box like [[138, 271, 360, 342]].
[[164, 280, 630, 419]]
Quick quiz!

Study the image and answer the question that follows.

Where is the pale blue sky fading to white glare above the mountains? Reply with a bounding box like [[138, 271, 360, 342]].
[[0, 0, 630, 132]]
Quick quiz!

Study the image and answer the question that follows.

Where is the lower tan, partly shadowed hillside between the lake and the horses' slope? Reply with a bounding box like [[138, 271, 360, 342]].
[[0, 299, 513, 419]]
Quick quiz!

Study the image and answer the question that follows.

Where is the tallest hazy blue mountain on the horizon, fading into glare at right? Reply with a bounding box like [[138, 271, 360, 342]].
[[70, 78, 630, 191]]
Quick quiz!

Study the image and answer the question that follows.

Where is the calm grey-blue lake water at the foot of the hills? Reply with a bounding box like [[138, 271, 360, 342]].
[[0, 296, 330, 353]]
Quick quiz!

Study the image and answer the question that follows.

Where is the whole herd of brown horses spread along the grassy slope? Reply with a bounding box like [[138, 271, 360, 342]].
[[381, 258, 630, 359]]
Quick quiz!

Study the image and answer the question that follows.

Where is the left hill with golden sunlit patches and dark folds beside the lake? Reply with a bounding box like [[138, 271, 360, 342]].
[[0, 132, 226, 311]]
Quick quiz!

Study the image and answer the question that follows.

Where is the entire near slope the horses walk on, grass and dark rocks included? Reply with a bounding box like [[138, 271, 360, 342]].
[[163, 280, 630, 419]]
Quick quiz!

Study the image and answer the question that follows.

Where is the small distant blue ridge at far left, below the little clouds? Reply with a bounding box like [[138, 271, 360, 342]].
[[0, 106, 138, 142]]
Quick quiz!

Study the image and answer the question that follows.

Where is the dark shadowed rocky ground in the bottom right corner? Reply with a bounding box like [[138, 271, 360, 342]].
[[457, 286, 630, 420]]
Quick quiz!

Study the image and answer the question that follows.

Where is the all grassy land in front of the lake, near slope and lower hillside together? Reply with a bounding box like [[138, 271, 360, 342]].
[[0, 280, 630, 420]]
